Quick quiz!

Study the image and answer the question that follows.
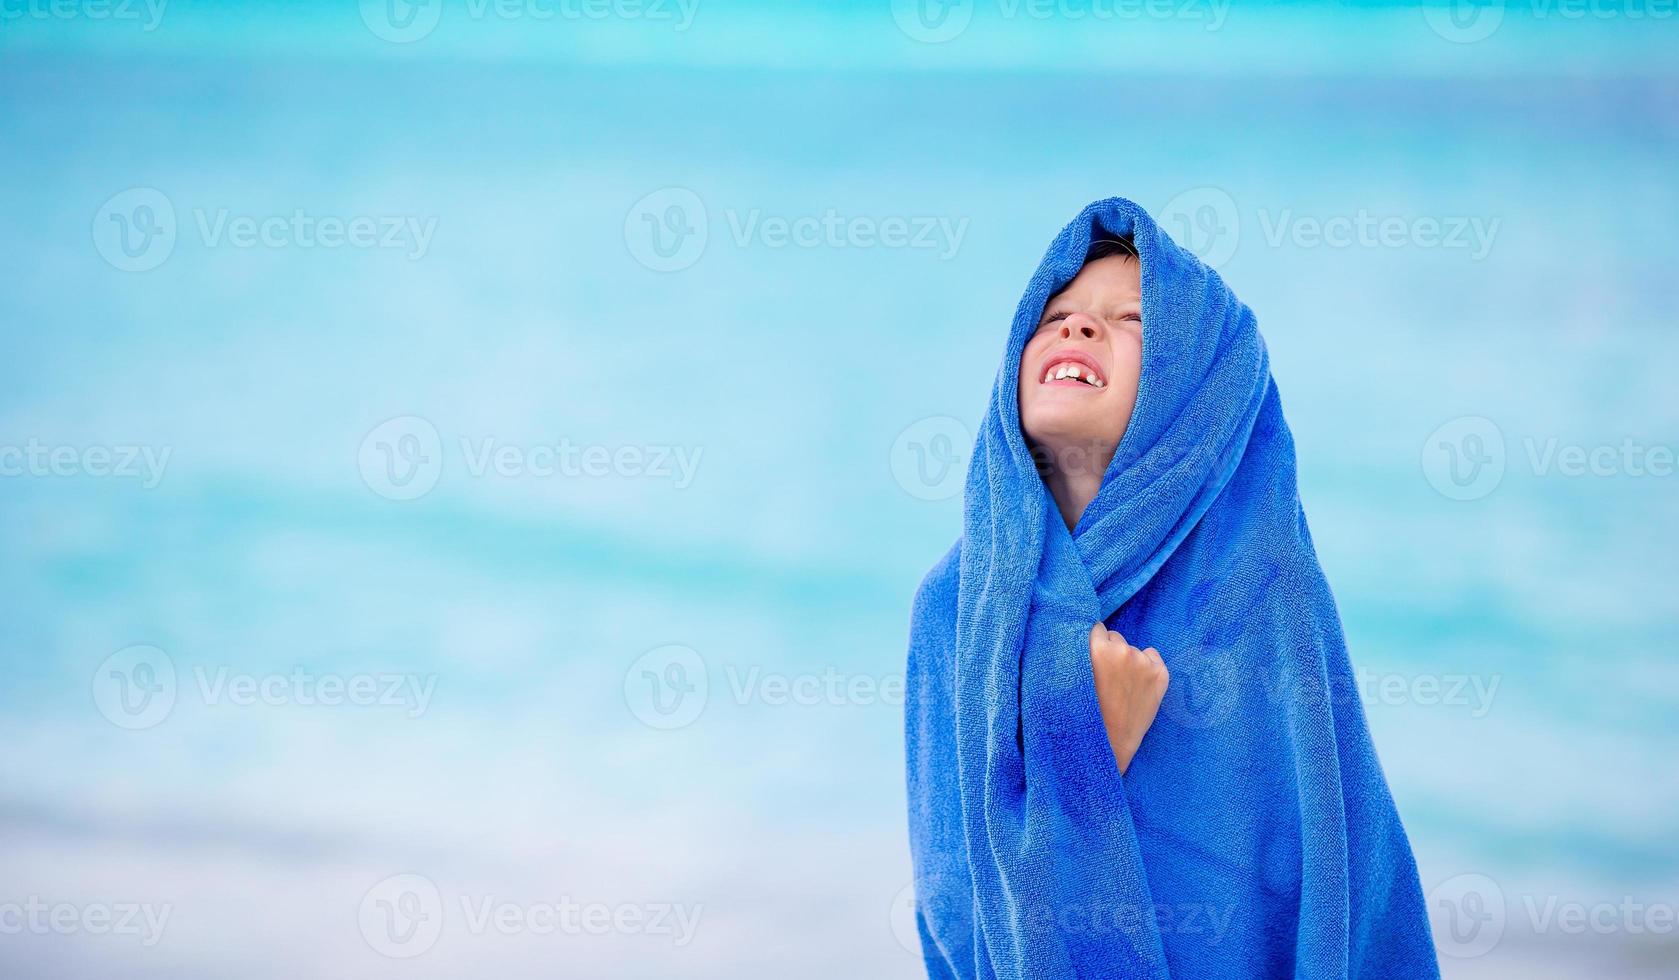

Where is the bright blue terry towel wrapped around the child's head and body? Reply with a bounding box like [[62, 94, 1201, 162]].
[[905, 198, 1439, 980]]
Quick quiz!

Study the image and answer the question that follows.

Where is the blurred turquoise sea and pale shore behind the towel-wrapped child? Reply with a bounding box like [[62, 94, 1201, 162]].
[[0, 0, 1679, 980]]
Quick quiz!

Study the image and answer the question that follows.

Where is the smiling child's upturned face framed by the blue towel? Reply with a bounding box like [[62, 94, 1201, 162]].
[[1021, 255, 1143, 453]]
